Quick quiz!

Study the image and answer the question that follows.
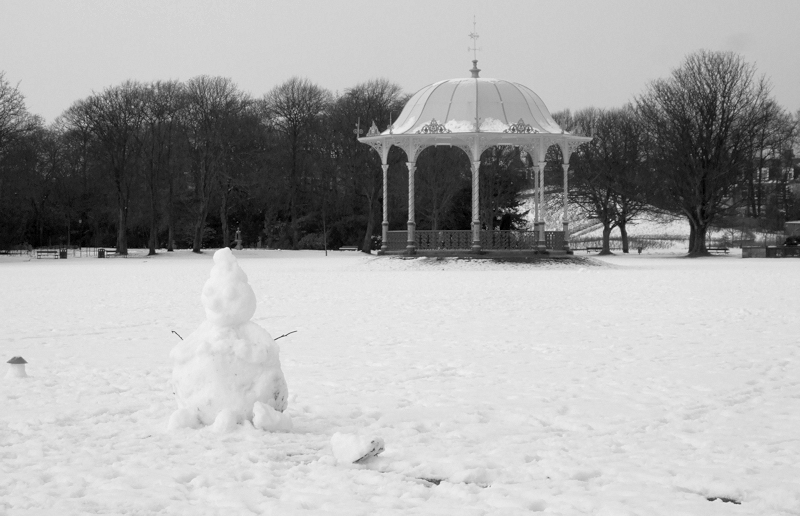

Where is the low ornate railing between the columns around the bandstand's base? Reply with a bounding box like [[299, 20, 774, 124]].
[[386, 230, 564, 251]]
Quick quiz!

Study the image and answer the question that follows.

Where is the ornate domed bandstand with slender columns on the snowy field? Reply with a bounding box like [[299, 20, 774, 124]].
[[358, 59, 591, 254]]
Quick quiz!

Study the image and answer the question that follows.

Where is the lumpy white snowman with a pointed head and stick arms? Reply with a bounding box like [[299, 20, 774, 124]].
[[169, 248, 292, 432]]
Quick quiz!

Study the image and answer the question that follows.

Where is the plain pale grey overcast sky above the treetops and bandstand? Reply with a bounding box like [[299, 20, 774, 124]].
[[0, 0, 800, 122]]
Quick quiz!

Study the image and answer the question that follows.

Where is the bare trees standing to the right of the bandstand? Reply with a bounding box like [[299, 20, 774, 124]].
[[555, 51, 800, 256]]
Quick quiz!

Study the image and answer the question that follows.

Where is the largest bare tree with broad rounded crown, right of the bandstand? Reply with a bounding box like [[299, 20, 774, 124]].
[[636, 50, 770, 256]]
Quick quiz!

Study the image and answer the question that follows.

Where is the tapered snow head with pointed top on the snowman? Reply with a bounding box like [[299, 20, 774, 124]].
[[200, 247, 256, 326]]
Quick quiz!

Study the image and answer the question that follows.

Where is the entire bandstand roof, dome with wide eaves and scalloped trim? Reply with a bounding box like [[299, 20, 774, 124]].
[[358, 60, 591, 164]]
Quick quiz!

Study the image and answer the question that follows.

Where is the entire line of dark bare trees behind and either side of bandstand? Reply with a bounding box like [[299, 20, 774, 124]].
[[0, 51, 800, 255]]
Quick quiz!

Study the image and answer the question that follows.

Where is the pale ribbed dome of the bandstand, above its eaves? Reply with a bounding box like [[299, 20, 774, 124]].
[[382, 78, 562, 135]]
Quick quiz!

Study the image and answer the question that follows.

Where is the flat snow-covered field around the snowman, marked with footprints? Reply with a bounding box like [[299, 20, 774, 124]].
[[0, 251, 800, 516]]
